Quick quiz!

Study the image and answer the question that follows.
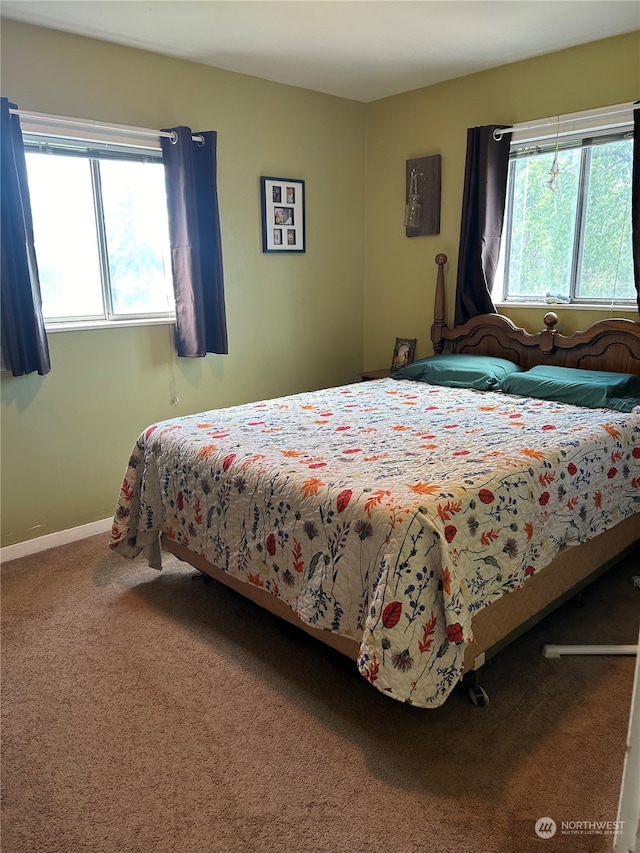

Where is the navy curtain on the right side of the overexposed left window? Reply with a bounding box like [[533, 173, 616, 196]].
[[161, 127, 229, 358]]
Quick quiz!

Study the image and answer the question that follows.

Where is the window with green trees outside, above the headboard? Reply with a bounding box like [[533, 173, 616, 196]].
[[494, 115, 636, 306]]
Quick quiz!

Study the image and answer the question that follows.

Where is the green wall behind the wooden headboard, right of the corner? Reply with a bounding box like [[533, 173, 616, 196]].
[[364, 32, 640, 369]]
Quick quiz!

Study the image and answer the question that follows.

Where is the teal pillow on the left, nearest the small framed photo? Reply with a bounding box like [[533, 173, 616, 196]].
[[392, 353, 521, 391]]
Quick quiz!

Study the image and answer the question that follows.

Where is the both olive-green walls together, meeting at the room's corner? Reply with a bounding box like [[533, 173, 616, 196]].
[[0, 21, 640, 546]]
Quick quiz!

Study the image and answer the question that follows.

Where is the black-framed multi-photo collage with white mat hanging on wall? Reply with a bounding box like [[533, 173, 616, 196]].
[[260, 175, 307, 254]]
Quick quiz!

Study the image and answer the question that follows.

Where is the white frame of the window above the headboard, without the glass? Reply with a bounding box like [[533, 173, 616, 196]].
[[494, 108, 636, 310]]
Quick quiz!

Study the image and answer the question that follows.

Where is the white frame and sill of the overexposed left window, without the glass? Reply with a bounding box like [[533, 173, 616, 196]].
[[22, 129, 176, 332]]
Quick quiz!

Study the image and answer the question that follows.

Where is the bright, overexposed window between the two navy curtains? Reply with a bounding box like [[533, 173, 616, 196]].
[[24, 134, 175, 328]]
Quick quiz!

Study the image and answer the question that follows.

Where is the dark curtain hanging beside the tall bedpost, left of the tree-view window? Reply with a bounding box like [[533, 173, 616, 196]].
[[455, 124, 511, 325]]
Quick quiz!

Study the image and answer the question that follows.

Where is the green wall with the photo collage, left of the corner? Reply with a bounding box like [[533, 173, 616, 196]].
[[1, 20, 366, 546]]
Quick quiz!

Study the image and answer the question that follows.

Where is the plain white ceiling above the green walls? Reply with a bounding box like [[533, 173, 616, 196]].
[[0, 0, 640, 102]]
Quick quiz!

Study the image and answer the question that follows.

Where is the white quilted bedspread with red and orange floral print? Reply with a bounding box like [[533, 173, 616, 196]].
[[110, 379, 640, 707]]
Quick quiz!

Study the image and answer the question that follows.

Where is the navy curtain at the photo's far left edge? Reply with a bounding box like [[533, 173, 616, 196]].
[[0, 98, 51, 376]]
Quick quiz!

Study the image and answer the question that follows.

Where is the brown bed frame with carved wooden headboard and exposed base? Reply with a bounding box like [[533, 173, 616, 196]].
[[162, 254, 640, 705]]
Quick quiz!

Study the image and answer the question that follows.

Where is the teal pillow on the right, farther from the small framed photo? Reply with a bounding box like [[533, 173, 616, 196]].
[[500, 364, 640, 412]]
